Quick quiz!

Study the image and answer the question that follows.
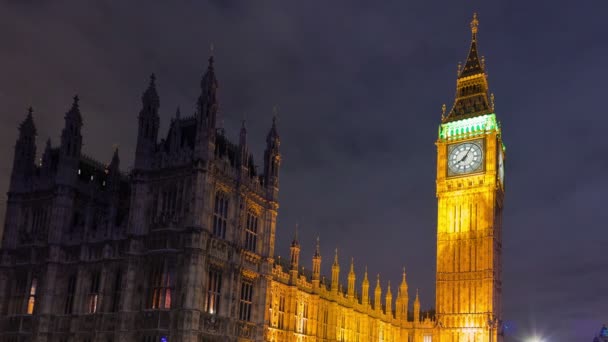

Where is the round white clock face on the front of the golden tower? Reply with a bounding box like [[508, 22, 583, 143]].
[[448, 140, 483, 175]]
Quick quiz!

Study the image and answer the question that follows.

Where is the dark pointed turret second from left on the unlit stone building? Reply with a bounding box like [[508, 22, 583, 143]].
[[58, 95, 82, 184]]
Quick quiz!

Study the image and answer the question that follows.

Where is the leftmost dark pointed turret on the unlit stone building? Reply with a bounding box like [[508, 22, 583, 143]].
[[10, 107, 36, 192]]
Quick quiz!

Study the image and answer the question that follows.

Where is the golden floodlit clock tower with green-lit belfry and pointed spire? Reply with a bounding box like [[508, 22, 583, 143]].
[[436, 15, 505, 342]]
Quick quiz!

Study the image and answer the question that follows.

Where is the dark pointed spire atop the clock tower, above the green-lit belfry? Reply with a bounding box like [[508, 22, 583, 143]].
[[443, 13, 493, 122]]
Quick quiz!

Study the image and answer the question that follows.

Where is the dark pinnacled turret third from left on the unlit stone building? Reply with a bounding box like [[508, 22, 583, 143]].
[[135, 74, 160, 170]]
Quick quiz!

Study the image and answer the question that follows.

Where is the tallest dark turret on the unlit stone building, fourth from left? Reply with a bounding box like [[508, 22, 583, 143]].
[[195, 56, 218, 160]]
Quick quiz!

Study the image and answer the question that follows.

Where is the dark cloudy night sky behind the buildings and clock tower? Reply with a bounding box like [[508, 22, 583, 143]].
[[0, 0, 608, 341]]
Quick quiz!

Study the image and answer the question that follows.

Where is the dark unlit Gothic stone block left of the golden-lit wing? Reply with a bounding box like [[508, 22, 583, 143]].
[[0, 59, 281, 341]]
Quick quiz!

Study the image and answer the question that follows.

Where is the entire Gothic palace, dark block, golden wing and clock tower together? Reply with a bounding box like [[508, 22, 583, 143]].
[[0, 17, 505, 342]]
